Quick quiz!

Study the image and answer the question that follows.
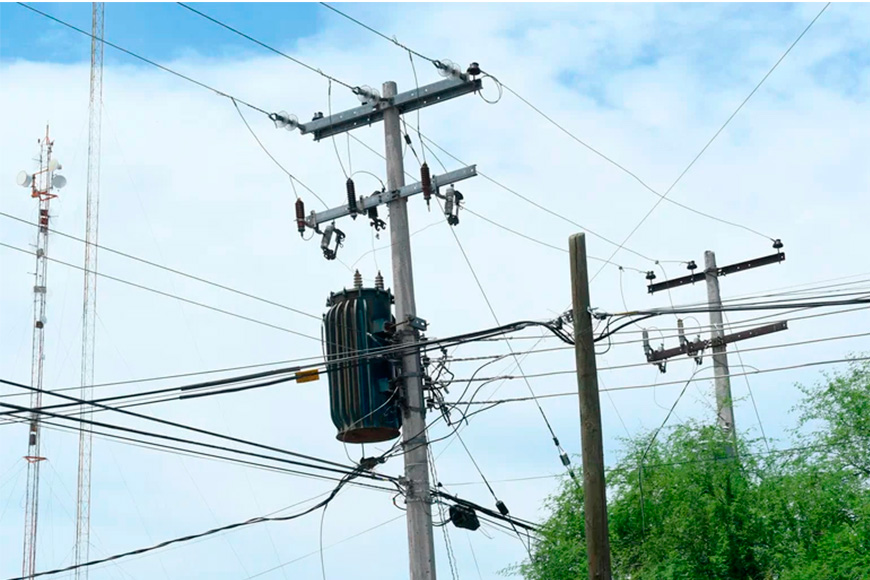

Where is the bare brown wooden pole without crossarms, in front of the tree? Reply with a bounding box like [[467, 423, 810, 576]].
[[569, 234, 611, 580]]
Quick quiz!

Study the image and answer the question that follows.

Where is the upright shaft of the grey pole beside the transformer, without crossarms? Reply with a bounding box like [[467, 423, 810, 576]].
[[383, 81, 435, 580]]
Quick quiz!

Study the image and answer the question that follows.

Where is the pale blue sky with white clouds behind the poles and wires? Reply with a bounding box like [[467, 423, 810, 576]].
[[0, 3, 870, 580]]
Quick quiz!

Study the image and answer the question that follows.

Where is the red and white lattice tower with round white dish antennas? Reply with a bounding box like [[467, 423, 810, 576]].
[[18, 126, 66, 578]]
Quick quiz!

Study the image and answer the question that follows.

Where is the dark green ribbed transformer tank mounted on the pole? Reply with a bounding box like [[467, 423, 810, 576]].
[[323, 287, 402, 443]]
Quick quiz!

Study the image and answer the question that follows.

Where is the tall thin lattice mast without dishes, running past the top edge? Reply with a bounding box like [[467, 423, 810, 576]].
[[74, 2, 105, 580]]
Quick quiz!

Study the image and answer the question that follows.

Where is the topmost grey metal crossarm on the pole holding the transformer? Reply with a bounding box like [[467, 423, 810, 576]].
[[297, 75, 483, 141]]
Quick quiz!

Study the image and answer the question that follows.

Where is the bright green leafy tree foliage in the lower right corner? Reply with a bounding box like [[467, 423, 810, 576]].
[[516, 362, 870, 580]]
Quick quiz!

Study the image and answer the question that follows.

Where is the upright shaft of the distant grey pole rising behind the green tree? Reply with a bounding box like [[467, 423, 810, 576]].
[[704, 250, 734, 434]]
